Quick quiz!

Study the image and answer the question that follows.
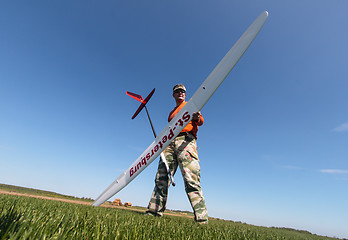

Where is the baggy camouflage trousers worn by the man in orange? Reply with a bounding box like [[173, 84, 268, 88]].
[[148, 134, 208, 221]]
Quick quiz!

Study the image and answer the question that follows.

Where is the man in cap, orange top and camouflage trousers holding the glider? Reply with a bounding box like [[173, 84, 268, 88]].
[[147, 84, 208, 224]]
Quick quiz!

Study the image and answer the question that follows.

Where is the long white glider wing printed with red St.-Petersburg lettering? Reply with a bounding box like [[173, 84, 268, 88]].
[[92, 11, 268, 206]]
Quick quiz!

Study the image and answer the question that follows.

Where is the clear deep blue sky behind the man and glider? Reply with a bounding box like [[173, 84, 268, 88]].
[[0, 0, 348, 238]]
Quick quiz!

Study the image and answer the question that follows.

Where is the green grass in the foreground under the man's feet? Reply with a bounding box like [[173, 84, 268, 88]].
[[0, 195, 338, 240]]
